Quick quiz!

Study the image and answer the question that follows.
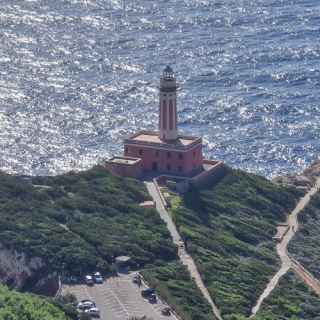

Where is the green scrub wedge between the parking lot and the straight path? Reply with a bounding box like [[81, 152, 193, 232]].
[[143, 262, 215, 320]]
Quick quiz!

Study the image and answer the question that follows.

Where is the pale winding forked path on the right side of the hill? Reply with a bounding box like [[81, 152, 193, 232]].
[[251, 177, 320, 317]]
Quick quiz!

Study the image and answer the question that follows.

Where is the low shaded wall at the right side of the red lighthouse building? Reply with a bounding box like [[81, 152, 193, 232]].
[[190, 160, 227, 188]]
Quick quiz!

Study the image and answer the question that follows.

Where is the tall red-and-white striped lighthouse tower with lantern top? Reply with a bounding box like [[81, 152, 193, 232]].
[[159, 66, 178, 141]]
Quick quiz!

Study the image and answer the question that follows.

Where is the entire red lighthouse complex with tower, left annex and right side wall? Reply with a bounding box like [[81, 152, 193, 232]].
[[105, 67, 222, 181]]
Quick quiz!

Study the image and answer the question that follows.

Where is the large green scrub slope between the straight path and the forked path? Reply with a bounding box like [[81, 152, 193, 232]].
[[171, 169, 300, 319]]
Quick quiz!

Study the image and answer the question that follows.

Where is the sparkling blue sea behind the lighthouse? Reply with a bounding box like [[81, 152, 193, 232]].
[[0, 0, 320, 177]]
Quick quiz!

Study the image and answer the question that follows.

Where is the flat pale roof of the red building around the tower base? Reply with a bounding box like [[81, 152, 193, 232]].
[[124, 131, 202, 149]]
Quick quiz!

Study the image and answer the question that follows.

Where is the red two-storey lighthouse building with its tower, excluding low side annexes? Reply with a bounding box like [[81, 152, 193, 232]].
[[124, 67, 203, 176]]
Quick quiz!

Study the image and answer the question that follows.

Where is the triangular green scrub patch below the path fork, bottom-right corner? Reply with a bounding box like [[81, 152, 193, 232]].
[[254, 272, 320, 320]]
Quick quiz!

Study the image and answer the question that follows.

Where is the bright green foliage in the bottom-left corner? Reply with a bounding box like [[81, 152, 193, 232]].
[[0, 286, 70, 320]]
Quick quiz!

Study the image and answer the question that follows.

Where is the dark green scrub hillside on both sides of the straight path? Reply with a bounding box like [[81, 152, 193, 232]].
[[0, 167, 312, 320]]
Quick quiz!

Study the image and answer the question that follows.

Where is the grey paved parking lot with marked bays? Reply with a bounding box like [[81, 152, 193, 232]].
[[62, 274, 177, 320]]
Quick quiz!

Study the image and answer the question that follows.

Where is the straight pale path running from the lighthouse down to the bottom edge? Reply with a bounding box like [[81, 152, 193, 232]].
[[145, 181, 222, 320]]
